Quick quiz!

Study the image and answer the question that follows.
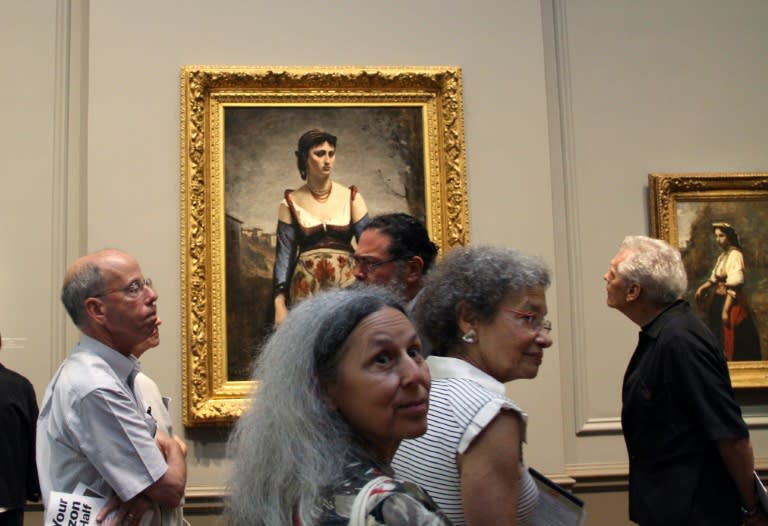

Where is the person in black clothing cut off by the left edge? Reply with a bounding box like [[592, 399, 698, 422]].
[[0, 337, 40, 526]]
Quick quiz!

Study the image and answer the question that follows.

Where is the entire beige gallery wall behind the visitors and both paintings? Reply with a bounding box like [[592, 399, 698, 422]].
[[0, 0, 768, 524]]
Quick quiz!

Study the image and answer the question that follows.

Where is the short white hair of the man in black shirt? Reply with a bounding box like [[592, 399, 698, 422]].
[[616, 236, 688, 305]]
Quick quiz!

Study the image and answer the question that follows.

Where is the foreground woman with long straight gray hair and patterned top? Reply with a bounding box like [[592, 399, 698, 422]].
[[227, 287, 450, 526]]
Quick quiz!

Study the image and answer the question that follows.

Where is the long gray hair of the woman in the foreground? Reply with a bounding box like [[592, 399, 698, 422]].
[[227, 287, 404, 526]]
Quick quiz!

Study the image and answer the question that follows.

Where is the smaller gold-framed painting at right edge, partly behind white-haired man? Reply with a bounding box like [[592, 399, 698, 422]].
[[648, 173, 768, 388]]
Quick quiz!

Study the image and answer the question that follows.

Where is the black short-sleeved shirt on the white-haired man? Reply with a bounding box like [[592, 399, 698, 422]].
[[621, 301, 749, 526]]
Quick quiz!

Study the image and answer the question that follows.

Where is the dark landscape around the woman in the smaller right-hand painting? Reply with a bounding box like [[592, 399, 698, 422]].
[[677, 199, 768, 360]]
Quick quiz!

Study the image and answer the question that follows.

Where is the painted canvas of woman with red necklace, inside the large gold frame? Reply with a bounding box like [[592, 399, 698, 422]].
[[224, 106, 426, 381]]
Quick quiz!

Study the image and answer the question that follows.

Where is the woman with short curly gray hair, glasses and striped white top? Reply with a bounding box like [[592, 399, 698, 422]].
[[392, 246, 552, 525]]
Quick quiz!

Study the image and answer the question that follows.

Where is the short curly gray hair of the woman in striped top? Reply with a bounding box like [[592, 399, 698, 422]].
[[414, 246, 550, 356]]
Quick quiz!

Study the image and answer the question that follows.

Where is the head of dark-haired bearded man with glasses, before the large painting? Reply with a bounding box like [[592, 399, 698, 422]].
[[354, 213, 437, 309]]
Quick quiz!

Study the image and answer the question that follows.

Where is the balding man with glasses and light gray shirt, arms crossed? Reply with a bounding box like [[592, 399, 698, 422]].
[[37, 250, 187, 526]]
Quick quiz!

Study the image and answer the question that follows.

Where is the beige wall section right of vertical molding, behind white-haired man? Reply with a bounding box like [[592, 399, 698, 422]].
[[545, 0, 768, 474]]
